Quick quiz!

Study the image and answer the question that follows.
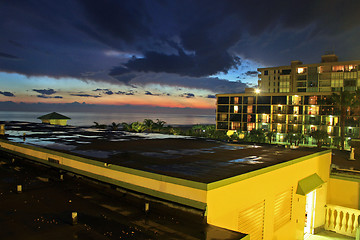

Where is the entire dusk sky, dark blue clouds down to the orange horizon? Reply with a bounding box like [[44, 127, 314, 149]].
[[0, 0, 360, 111]]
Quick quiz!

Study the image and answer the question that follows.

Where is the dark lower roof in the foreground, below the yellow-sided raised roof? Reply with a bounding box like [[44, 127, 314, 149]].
[[0, 153, 240, 240]]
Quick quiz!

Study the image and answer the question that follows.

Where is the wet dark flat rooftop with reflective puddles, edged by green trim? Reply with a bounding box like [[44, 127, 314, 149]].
[[0, 122, 322, 183]]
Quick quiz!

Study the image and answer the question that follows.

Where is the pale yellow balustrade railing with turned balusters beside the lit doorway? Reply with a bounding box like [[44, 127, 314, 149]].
[[325, 204, 360, 237]]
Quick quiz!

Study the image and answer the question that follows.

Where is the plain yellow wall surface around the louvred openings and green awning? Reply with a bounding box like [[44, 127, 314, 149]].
[[207, 153, 331, 240]]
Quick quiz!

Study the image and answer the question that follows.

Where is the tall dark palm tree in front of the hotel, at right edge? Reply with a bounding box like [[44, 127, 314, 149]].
[[318, 90, 360, 150]]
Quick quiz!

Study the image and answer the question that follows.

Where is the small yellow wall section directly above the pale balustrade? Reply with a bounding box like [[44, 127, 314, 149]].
[[328, 178, 359, 209]]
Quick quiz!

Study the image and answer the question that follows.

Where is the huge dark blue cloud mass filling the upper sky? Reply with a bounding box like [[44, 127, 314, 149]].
[[0, 0, 360, 89]]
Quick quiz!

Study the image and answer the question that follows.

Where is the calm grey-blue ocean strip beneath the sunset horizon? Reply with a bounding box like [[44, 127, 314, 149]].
[[0, 111, 215, 126]]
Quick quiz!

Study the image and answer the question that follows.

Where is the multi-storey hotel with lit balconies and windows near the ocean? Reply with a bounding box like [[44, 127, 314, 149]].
[[216, 54, 360, 147]]
